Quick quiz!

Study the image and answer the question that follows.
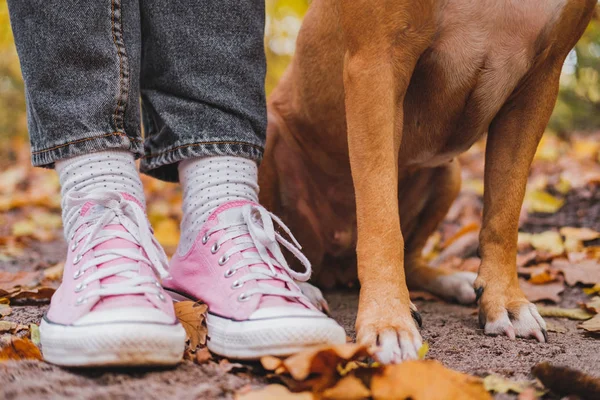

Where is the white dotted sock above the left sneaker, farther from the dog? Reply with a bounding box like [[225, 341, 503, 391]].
[[56, 150, 146, 241]]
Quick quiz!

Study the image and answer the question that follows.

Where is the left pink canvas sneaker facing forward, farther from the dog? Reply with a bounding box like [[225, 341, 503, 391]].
[[40, 192, 185, 366]]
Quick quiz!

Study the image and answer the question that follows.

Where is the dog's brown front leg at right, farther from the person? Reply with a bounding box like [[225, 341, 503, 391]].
[[475, 65, 560, 342]]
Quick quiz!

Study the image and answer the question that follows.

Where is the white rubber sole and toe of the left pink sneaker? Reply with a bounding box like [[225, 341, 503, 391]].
[[40, 319, 186, 367]]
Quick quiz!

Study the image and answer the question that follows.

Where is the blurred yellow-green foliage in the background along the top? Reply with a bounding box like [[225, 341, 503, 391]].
[[0, 0, 600, 145]]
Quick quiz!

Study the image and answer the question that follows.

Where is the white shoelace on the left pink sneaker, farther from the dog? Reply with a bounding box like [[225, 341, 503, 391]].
[[67, 192, 168, 304]]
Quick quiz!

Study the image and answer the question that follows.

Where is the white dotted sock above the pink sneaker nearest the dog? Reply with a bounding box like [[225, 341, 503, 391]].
[[177, 156, 258, 254]]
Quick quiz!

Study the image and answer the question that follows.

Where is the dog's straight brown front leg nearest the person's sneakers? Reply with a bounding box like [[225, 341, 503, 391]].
[[339, 0, 433, 363]]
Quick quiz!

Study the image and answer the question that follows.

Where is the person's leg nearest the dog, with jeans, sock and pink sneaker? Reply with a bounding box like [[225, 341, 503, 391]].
[[141, 0, 345, 358]]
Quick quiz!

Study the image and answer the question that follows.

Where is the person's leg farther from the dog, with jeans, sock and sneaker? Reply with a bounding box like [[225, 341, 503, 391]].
[[9, 0, 185, 366]]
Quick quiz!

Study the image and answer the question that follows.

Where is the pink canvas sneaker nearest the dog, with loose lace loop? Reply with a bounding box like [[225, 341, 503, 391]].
[[163, 201, 346, 359]]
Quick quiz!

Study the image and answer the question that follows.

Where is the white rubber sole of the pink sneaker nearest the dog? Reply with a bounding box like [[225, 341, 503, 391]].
[[167, 290, 346, 360]]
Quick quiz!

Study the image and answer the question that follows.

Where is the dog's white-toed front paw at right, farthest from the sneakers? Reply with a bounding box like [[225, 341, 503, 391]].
[[475, 281, 548, 343]]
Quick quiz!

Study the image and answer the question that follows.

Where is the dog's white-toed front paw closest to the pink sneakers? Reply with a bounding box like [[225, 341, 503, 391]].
[[356, 304, 423, 364]]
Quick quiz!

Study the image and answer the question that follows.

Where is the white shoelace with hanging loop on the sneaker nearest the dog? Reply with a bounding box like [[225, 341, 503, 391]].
[[202, 204, 311, 301]]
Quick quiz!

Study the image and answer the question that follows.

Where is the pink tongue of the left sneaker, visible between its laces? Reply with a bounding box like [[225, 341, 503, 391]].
[[80, 202, 154, 311]]
